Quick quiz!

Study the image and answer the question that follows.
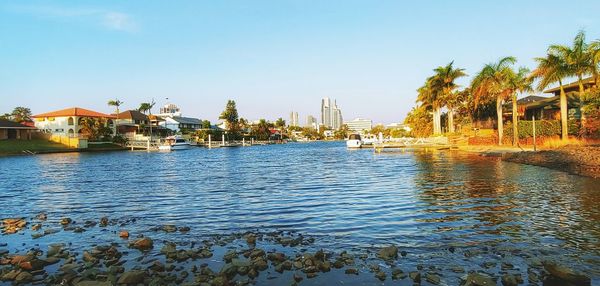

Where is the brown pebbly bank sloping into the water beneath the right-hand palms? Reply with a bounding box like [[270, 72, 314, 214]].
[[502, 146, 600, 178]]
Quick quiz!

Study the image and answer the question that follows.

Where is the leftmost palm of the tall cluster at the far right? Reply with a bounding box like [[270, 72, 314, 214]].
[[530, 53, 570, 140]]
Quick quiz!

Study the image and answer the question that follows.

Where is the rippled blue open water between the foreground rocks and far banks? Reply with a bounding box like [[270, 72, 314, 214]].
[[0, 143, 600, 284]]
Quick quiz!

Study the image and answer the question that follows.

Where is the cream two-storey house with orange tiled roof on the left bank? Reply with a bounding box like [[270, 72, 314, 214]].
[[32, 107, 116, 137]]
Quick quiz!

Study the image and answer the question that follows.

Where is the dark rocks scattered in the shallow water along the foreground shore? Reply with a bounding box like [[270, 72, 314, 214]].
[[0, 213, 591, 286]]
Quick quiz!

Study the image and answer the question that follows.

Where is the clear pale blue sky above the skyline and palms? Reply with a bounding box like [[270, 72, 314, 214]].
[[0, 0, 600, 124]]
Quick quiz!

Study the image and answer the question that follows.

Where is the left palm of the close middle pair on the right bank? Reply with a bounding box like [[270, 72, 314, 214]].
[[471, 57, 517, 145]]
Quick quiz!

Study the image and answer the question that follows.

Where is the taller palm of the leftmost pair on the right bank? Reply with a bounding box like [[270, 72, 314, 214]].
[[434, 61, 467, 133]]
